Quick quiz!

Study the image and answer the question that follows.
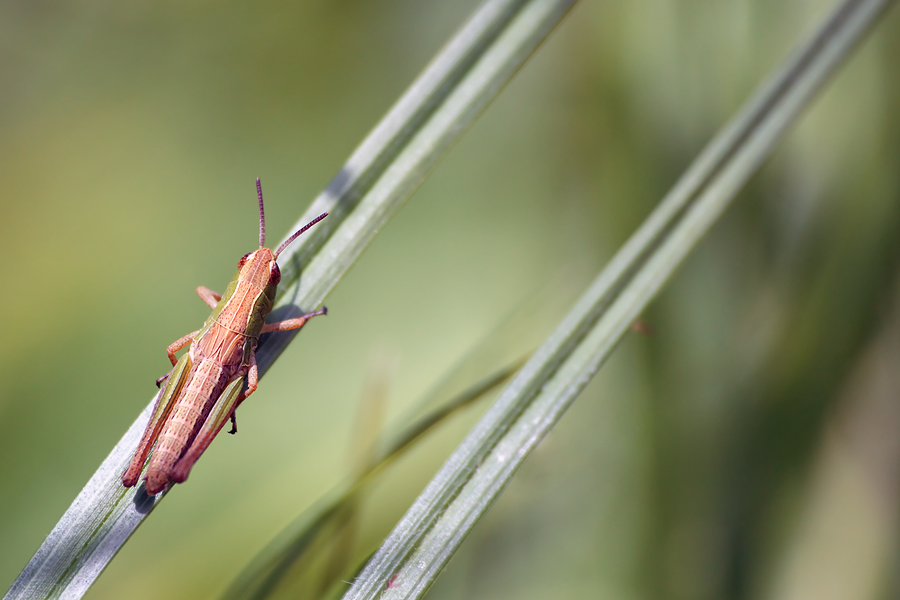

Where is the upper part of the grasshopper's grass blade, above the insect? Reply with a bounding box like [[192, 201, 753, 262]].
[[257, 0, 574, 372]]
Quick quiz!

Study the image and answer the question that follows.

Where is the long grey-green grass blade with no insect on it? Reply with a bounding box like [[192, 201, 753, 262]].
[[344, 0, 889, 600]]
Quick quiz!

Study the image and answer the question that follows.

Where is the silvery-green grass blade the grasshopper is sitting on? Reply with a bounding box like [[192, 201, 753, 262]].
[[6, 0, 574, 598]]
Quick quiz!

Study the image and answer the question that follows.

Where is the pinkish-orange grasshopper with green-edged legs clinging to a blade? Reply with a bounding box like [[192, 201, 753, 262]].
[[122, 179, 328, 494]]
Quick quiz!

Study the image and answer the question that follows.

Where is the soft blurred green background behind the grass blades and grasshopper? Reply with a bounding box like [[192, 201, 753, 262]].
[[0, 0, 900, 599]]
